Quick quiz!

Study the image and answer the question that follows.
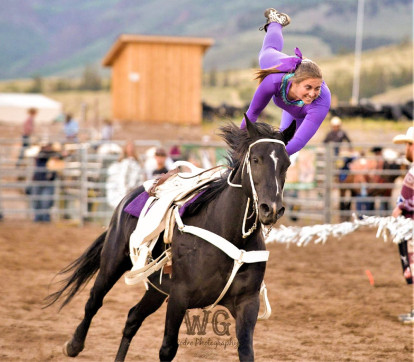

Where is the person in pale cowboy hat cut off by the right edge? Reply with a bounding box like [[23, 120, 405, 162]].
[[392, 127, 414, 324]]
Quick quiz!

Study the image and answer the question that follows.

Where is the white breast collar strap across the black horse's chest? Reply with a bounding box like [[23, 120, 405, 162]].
[[174, 207, 269, 310]]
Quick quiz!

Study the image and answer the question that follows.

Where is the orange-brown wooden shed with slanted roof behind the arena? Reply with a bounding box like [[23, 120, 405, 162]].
[[102, 34, 213, 124]]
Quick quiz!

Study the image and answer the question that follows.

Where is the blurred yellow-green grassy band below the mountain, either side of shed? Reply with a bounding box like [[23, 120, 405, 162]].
[[0, 43, 413, 122]]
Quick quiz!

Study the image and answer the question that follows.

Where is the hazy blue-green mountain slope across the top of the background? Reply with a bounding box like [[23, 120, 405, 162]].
[[0, 0, 413, 79]]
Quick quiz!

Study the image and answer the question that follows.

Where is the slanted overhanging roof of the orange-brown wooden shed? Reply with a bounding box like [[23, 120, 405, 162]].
[[102, 34, 214, 67]]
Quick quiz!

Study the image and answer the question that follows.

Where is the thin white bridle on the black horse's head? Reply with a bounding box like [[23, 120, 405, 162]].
[[227, 138, 286, 238]]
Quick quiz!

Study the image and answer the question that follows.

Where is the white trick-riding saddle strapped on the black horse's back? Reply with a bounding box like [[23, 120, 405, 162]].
[[125, 161, 223, 285]]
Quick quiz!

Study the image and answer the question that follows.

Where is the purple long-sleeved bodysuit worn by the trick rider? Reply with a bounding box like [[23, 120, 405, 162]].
[[241, 23, 331, 155]]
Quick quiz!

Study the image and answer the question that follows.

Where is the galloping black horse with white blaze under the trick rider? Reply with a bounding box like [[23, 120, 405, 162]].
[[46, 117, 295, 361]]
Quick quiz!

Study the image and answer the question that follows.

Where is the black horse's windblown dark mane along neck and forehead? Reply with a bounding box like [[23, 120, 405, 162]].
[[185, 122, 281, 215]]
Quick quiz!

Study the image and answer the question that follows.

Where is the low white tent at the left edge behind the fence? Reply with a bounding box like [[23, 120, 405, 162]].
[[0, 93, 62, 124]]
